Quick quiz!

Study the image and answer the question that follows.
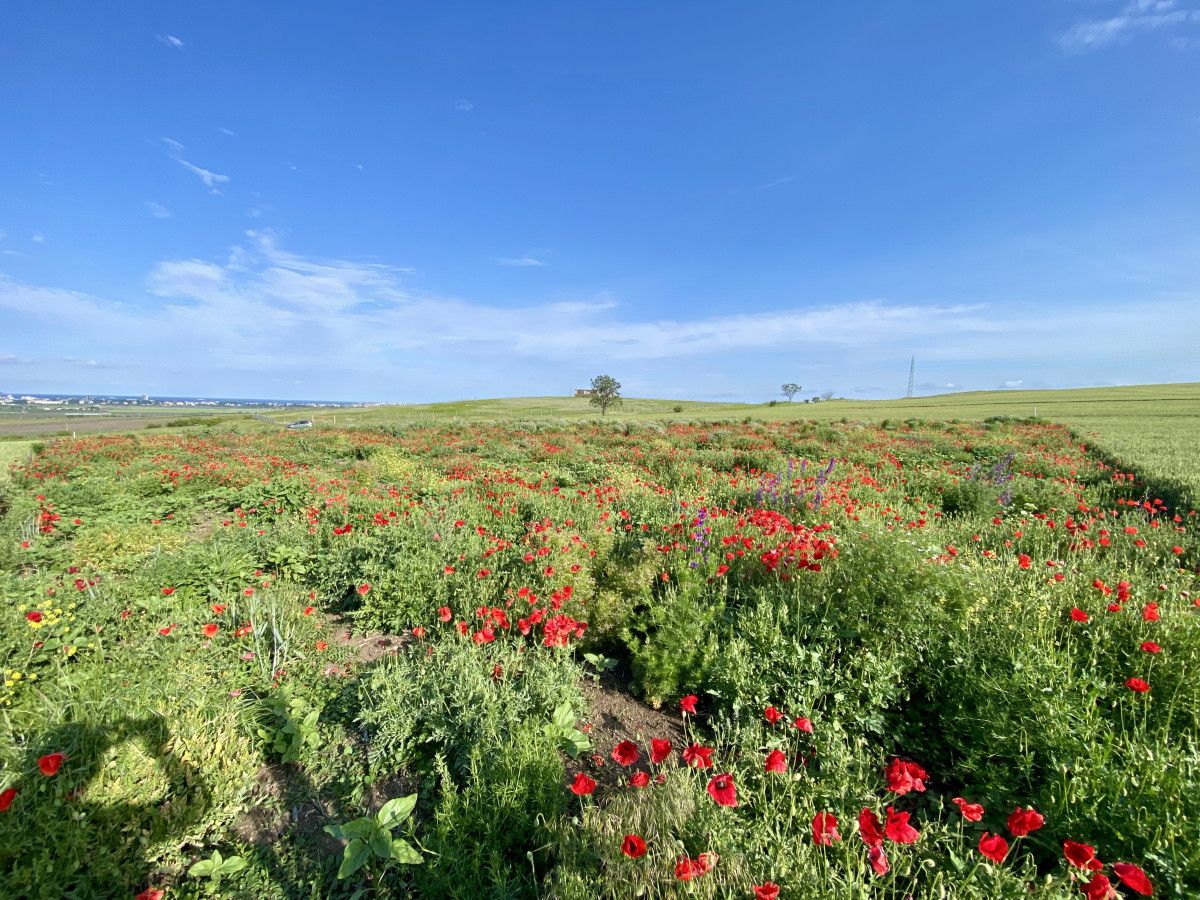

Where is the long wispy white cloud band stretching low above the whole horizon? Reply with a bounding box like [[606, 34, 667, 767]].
[[0, 232, 1200, 400]]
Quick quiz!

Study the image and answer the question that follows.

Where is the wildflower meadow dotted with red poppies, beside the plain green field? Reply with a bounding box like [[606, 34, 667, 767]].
[[0, 421, 1200, 900]]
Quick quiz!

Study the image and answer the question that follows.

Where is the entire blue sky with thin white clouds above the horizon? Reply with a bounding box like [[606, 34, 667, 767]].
[[0, 0, 1200, 402]]
